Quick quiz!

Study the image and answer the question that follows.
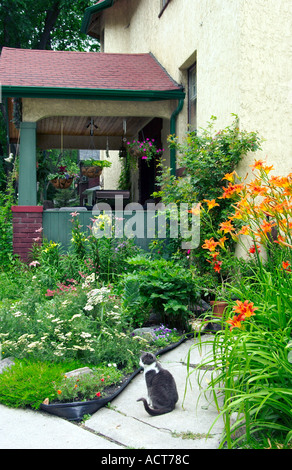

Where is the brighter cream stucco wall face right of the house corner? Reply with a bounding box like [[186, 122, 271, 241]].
[[239, 0, 292, 174]]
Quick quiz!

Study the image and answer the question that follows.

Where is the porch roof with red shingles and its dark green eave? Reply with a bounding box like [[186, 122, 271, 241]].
[[0, 47, 184, 100]]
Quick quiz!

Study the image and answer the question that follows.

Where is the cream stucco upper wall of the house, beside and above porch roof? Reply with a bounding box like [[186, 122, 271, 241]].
[[104, 0, 292, 178]]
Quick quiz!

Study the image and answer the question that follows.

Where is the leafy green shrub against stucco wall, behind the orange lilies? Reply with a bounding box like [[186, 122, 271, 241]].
[[154, 114, 261, 269]]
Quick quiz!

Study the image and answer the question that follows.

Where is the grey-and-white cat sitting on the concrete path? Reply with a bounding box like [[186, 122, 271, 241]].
[[137, 352, 178, 416]]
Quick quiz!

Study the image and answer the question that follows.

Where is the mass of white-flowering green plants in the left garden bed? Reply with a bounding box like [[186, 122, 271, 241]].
[[0, 273, 139, 369]]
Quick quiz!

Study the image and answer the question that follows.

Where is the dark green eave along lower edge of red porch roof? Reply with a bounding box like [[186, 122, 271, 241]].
[[2, 85, 185, 101]]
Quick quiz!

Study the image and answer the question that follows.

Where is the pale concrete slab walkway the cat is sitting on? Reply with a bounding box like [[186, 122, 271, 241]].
[[0, 335, 223, 450]]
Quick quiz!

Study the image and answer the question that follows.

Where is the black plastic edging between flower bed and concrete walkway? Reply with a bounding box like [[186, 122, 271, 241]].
[[40, 333, 193, 421]]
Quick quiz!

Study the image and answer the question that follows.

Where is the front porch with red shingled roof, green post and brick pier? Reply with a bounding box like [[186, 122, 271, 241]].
[[0, 48, 185, 260]]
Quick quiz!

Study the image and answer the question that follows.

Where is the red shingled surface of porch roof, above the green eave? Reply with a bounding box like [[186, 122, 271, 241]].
[[0, 47, 181, 91]]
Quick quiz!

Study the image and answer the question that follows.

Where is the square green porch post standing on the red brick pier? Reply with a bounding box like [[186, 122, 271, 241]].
[[18, 122, 37, 206]]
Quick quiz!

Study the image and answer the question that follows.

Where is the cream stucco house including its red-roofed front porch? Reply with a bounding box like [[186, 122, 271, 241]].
[[0, 0, 292, 259]]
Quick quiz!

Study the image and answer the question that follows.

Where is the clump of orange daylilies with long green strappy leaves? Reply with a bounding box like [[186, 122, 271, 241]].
[[187, 160, 292, 447]]
